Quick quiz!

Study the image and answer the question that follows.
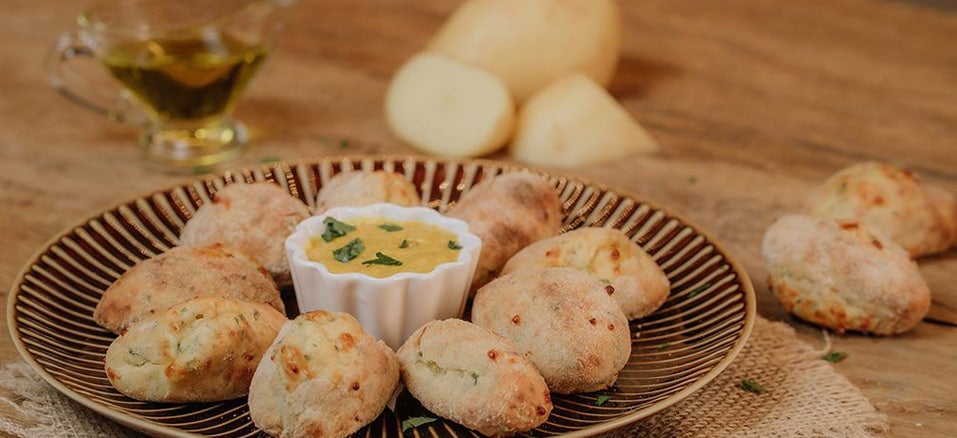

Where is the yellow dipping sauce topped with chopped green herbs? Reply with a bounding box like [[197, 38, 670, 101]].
[[305, 218, 461, 278]]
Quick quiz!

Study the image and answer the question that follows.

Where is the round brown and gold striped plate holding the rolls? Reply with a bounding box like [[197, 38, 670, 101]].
[[7, 156, 755, 437]]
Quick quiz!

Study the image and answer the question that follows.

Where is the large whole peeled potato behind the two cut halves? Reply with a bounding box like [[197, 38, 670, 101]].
[[429, 0, 622, 102]]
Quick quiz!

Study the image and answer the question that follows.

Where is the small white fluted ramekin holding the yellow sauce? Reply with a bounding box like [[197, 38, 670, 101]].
[[286, 203, 482, 349]]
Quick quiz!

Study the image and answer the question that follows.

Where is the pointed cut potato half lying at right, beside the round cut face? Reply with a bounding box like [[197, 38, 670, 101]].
[[509, 73, 658, 167]]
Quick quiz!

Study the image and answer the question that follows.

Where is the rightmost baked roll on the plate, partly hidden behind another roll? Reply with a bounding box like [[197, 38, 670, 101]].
[[502, 227, 670, 319]]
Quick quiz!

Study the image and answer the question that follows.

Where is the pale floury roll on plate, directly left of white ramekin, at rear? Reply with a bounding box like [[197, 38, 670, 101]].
[[179, 182, 310, 286]]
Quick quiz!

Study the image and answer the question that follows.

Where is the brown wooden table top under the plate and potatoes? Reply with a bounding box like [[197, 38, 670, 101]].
[[0, 0, 957, 437]]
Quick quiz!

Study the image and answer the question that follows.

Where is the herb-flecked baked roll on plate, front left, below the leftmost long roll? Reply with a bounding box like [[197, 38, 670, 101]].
[[105, 297, 286, 402]]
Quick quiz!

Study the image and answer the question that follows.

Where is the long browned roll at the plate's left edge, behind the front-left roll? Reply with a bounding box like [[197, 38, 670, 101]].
[[93, 244, 286, 333]]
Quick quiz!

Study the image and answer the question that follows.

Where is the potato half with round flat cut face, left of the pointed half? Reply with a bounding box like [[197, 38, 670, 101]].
[[385, 52, 515, 156]]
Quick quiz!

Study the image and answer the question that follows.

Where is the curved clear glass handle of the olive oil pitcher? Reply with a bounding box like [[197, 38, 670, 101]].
[[46, 33, 146, 125]]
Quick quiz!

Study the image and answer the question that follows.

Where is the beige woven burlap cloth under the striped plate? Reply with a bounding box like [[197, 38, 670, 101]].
[[0, 317, 888, 438]]
